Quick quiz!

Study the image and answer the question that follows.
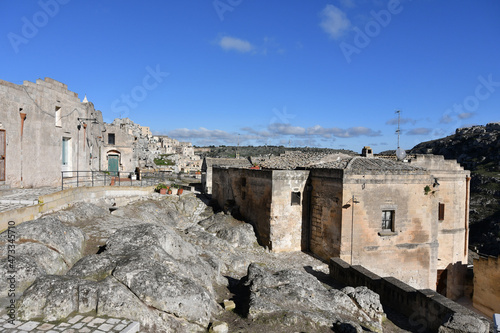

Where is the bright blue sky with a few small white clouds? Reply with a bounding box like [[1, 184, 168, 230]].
[[0, 0, 500, 152]]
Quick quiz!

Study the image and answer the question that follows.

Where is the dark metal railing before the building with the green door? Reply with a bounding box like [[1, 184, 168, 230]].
[[61, 171, 173, 190]]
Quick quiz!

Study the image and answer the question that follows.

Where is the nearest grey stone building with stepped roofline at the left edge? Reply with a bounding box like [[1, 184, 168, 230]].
[[0, 78, 104, 187]]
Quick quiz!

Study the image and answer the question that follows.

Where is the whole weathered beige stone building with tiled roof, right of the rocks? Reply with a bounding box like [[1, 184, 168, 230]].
[[212, 155, 470, 294]]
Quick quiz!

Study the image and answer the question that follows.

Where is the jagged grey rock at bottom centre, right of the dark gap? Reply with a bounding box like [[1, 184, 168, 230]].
[[245, 263, 382, 332]]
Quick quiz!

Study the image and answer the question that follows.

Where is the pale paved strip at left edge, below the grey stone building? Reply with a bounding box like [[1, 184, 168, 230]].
[[0, 187, 61, 212]]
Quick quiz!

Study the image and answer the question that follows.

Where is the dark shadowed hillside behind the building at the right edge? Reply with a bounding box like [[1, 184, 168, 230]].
[[410, 123, 500, 256]]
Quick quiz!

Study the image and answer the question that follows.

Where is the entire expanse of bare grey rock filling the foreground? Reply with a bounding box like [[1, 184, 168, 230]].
[[0, 195, 422, 332]]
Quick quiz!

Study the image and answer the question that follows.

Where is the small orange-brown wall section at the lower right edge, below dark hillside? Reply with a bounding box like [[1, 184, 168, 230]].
[[472, 257, 500, 316]]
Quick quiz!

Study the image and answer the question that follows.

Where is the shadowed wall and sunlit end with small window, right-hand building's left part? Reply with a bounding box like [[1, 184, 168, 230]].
[[212, 167, 309, 252]]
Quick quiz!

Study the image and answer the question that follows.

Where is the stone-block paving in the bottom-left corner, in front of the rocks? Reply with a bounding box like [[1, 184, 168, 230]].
[[0, 314, 139, 333]]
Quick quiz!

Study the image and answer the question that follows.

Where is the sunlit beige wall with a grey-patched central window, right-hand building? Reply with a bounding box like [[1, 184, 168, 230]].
[[340, 173, 438, 289]]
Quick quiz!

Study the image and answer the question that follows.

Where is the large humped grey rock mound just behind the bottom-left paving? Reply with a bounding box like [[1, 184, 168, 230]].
[[19, 224, 220, 332]]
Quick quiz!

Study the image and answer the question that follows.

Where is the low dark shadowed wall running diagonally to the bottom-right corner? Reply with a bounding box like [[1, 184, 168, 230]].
[[330, 258, 489, 333]]
